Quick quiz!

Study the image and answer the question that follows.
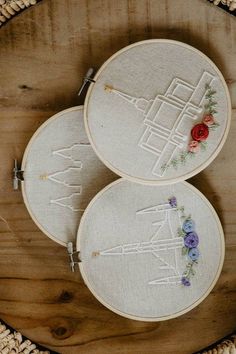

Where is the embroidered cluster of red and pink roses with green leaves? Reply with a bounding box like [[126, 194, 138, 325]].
[[161, 85, 219, 171]]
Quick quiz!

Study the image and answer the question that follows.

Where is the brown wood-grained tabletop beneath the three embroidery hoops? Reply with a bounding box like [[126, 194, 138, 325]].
[[0, 0, 236, 354]]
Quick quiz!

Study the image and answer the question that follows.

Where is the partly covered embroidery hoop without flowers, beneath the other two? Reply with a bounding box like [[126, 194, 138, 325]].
[[19, 106, 116, 246]]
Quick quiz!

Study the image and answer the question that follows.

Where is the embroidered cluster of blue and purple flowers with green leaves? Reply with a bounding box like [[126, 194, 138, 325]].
[[169, 197, 200, 286]]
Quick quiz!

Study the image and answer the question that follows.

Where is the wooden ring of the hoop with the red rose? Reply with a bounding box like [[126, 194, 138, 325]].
[[84, 39, 231, 185]]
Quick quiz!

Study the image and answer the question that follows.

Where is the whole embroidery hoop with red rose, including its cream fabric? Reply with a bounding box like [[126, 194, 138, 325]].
[[84, 39, 231, 185]]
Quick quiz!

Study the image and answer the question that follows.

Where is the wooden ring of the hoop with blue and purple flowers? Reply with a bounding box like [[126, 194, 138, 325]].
[[76, 178, 225, 322]]
